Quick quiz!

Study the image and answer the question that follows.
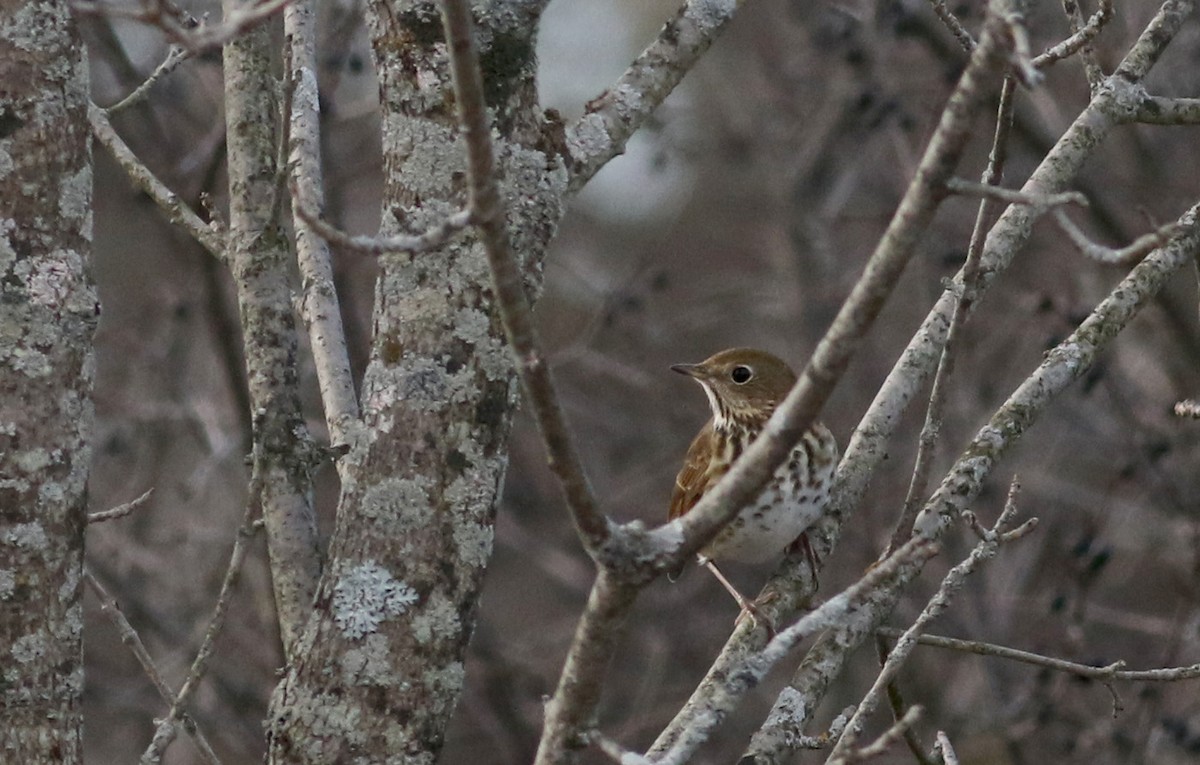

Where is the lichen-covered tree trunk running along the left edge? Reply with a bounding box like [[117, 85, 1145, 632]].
[[0, 0, 98, 764]]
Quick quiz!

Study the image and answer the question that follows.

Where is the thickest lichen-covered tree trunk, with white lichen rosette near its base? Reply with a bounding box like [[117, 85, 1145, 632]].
[[270, 0, 566, 764]]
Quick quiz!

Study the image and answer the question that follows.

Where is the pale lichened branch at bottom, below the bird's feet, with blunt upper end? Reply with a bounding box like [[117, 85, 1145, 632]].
[[648, 538, 937, 765]]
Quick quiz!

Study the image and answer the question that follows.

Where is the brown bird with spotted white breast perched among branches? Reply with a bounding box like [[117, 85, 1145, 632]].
[[670, 348, 838, 630]]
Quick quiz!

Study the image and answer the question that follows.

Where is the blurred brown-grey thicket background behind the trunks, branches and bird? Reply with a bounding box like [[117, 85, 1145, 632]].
[[80, 0, 1200, 764]]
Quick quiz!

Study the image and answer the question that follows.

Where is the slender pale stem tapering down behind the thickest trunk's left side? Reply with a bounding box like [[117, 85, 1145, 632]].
[[283, 0, 359, 450]]
